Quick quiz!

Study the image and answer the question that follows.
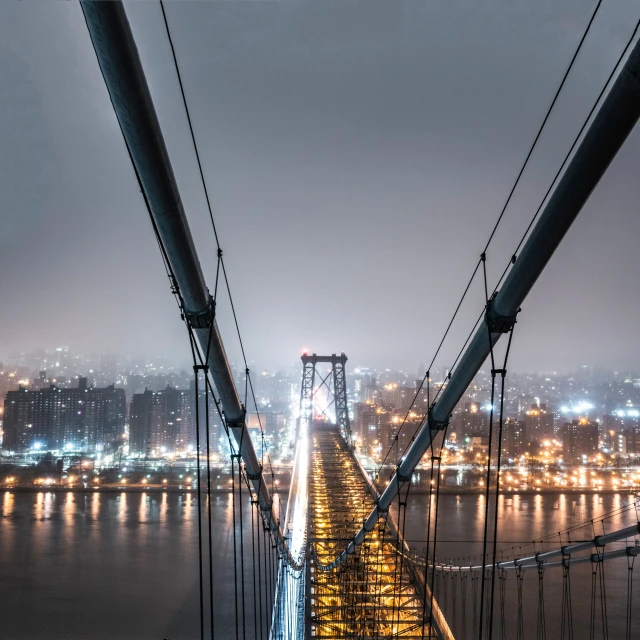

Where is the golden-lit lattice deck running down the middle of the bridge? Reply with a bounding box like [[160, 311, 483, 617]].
[[305, 422, 444, 640]]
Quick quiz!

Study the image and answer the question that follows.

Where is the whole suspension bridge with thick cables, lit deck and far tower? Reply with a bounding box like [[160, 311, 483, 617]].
[[81, 0, 640, 640]]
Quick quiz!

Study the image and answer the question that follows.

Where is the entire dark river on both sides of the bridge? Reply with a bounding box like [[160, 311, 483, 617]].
[[0, 492, 640, 640]]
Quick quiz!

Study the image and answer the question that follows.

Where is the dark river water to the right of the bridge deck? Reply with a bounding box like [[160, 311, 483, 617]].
[[405, 494, 640, 640]]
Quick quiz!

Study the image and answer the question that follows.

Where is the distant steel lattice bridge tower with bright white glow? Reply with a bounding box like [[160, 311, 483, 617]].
[[300, 352, 353, 446]]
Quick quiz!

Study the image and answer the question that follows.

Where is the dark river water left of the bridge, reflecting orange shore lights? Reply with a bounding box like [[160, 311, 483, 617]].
[[0, 492, 266, 640]]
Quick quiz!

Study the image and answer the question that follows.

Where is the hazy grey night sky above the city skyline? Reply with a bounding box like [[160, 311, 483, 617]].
[[0, 0, 640, 371]]
